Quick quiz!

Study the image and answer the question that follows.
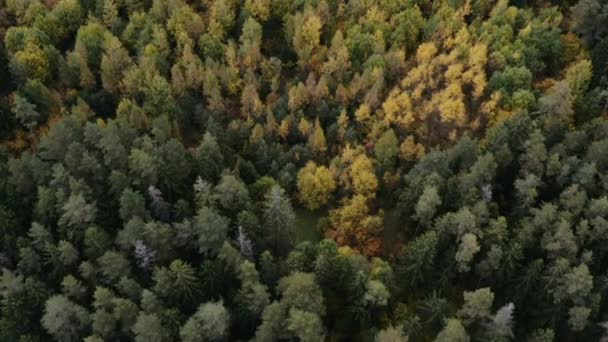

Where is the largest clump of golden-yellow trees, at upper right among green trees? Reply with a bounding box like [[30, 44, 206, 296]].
[[382, 27, 497, 148]]
